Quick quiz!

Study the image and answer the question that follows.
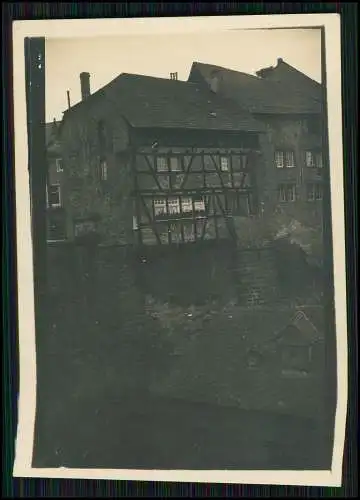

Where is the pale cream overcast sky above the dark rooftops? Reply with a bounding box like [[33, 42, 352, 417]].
[[45, 29, 321, 121]]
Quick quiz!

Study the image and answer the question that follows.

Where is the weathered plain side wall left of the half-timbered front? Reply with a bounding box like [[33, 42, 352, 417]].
[[62, 103, 133, 244]]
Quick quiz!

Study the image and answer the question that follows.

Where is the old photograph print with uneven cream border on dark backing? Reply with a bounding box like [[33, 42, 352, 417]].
[[14, 14, 347, 486]]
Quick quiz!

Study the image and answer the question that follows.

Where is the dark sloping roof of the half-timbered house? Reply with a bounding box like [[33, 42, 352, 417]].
[[64, 73, 263, 132]]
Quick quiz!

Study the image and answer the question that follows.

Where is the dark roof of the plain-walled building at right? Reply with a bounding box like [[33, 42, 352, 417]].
[[188, 62, 322, 114]]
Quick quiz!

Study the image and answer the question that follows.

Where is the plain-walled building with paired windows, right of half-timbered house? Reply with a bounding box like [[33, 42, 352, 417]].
[[189, 59, 326, 228]]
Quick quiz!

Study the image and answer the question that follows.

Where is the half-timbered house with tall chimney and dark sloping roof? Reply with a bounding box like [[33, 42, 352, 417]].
[[61, 73, 264, 250]]
